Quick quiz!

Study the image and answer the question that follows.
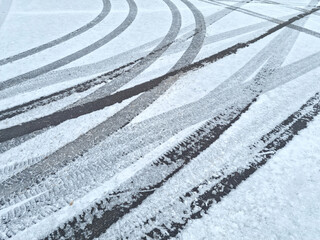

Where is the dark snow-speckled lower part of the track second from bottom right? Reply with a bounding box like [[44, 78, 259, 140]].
[[44, 100, 254, 239]]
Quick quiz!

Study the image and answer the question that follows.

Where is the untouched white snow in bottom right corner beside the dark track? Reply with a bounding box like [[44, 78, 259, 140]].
[[179, 114, 320, 240]]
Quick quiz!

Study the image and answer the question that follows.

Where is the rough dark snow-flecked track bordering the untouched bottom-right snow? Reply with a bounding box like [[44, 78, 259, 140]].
[[143, 93, 320, 239]]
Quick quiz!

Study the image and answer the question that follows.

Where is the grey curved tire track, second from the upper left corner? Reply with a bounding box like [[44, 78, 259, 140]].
[[0, 0, 137, 90]]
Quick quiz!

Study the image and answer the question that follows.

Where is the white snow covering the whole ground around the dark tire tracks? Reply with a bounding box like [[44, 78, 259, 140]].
[[0, 0, 320, 240]]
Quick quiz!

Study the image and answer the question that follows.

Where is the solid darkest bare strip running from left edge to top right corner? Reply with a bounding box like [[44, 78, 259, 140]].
[[0, 6, 320, 142]]
